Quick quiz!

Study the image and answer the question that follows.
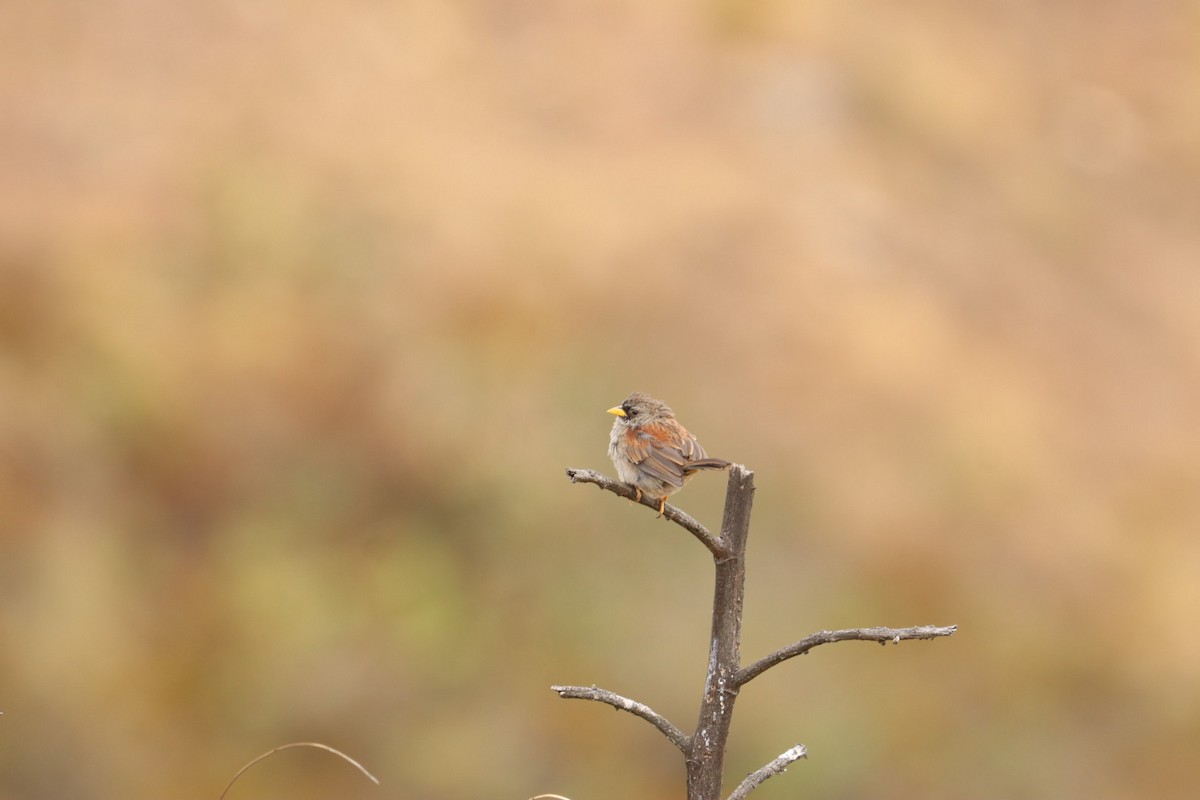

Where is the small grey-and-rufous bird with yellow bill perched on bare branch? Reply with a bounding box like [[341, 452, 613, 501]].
[[608, 392, 730, 517]]
